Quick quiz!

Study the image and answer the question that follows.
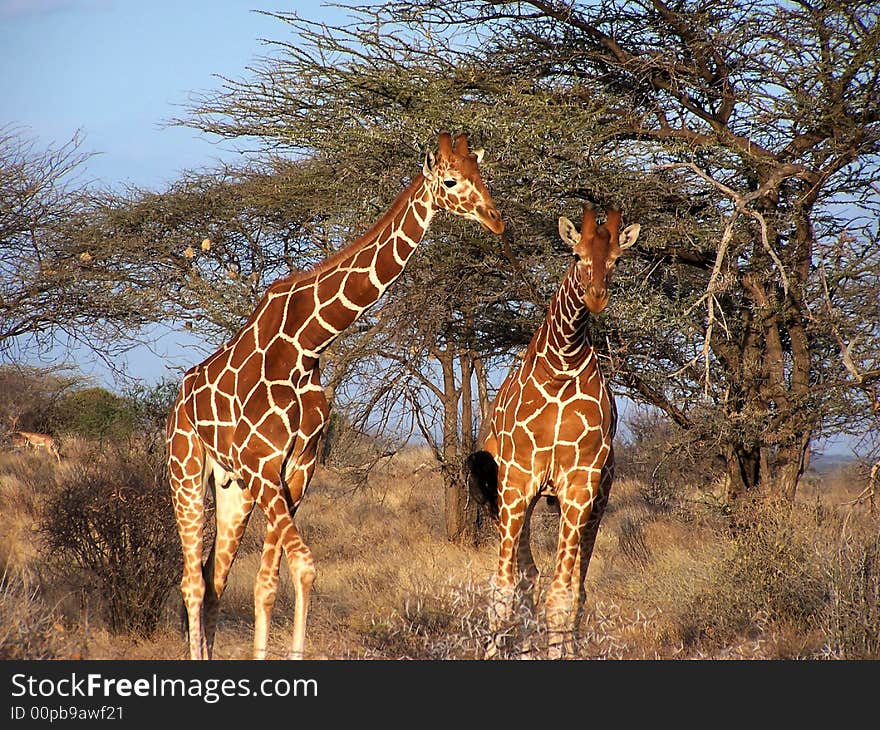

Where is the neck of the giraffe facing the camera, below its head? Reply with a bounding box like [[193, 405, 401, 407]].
[[535, 264, 595, 374]]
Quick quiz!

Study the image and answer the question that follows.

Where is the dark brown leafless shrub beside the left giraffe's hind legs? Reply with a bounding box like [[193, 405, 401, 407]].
[[42, 452, 181, 636]]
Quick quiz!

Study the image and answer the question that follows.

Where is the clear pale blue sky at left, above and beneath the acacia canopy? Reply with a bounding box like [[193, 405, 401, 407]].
[[0, 0, 357, 385]]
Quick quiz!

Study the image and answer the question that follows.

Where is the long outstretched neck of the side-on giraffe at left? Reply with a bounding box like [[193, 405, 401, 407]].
[[283, 174, 436, 357]]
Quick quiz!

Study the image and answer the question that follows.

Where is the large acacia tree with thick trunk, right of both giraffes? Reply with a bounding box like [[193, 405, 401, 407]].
[[360, 0, 880, 498]]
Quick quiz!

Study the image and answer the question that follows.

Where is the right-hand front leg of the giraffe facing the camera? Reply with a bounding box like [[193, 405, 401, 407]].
[[545, 470, 599, 659]]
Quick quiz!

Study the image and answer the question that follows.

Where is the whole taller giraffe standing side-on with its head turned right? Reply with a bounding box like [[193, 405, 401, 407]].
[[166, 132, 504, 659]]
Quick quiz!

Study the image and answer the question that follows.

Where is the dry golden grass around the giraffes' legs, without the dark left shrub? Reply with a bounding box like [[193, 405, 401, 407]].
[[0, 444, 880, 659]]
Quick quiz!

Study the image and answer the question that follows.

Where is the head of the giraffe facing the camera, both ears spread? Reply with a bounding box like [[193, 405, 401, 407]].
[[559, 203, 641, 314]]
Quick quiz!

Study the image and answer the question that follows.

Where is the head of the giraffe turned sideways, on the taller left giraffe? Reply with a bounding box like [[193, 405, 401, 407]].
[[422, 132, 504, 233]]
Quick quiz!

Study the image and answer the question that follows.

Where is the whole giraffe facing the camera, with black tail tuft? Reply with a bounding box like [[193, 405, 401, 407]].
[[467, 205, 640, 658]]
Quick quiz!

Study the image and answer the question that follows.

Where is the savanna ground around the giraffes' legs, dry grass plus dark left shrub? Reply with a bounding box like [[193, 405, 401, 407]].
[[0, 432, 880, 660]]
